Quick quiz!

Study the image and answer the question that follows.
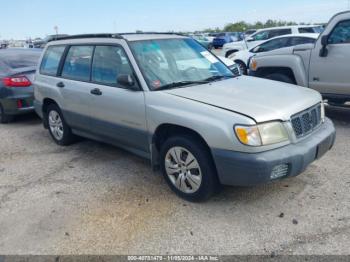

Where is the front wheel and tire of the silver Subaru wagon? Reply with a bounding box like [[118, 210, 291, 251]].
[[160, 135, 220, 202]]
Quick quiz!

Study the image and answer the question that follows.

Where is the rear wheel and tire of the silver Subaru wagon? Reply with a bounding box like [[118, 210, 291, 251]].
[[45, 104, 75, 146]]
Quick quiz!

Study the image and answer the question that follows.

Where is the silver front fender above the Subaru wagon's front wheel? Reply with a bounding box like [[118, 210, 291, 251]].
[[146, 92, 255, 151]]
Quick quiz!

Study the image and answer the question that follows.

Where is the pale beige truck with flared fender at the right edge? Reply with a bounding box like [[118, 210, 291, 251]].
[[249, 11, 350, 105]]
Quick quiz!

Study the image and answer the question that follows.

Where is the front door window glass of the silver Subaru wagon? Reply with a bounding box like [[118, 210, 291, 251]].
[[92, 46, 132, 86]]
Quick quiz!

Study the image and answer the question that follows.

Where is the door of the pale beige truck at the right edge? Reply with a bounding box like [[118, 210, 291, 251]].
[[309, 20, 350, 95]]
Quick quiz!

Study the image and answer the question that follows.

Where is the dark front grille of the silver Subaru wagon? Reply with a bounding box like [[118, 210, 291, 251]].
[[292, 104, 322, 138]]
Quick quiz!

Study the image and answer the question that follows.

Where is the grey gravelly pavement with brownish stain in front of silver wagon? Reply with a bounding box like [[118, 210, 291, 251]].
[[0, 105, 350, 255]]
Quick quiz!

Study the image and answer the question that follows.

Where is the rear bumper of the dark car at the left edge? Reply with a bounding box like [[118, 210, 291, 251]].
[[0, 95, 34, 115]]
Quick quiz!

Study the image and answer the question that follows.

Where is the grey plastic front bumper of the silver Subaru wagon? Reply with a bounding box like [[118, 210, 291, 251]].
[[212, 119, 336, 186]]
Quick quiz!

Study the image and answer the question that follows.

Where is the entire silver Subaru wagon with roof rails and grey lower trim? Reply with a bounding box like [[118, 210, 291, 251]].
[[35, 34, 335, 201]]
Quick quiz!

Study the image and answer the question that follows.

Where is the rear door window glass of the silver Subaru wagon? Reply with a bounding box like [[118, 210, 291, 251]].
[[62, 46, 94, 81]]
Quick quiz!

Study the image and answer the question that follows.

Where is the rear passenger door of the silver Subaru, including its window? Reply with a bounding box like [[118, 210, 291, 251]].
[[55, 45, 94, 131]]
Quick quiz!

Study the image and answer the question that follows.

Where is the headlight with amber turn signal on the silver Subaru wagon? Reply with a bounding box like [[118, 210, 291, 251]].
[[235, 122, 288, 146]]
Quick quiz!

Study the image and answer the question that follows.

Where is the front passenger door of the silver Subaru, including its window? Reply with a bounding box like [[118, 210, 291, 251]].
[[90, 45, 149, 152]]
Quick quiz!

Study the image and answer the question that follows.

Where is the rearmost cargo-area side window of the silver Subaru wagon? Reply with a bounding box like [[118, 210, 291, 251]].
[[40, 46, 65, 76]]
